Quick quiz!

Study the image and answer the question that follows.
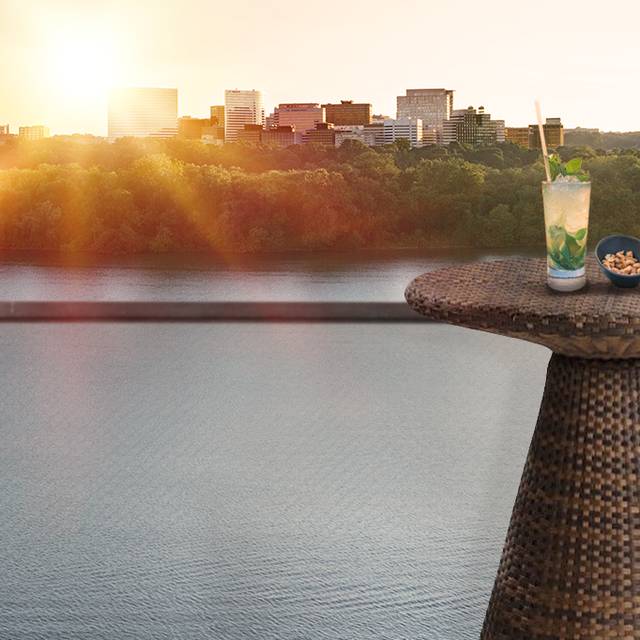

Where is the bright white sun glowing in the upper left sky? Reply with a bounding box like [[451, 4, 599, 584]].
[[49, 32, 115, 101]]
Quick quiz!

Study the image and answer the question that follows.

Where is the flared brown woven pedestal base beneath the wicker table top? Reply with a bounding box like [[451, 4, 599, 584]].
[[481, 354, 640, 640]]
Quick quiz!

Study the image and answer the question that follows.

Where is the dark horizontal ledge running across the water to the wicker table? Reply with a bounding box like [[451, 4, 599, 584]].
[[0, 301, 425, 322]]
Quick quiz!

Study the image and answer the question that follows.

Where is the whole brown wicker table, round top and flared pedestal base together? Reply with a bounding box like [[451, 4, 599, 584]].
[[405, 259, 640, 640]]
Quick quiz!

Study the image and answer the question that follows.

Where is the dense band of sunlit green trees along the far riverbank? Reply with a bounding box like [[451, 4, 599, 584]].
[[0, 138, 640, 253]]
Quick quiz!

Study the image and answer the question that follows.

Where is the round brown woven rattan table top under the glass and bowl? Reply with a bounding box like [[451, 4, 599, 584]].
[[405, 258, 640, 358]]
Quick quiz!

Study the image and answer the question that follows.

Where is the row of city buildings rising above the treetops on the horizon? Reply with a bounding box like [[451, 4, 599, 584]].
[[0, 87, 563, 148]]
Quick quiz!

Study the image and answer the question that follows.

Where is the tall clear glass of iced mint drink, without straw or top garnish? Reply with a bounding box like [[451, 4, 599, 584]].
[[542, 180, 591, 291]]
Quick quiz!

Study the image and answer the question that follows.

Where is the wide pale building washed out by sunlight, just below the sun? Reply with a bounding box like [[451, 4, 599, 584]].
[[109, 87, 178, 140]]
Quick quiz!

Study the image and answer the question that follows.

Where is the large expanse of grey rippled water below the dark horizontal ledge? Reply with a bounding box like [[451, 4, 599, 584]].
[[0, 324, 548, 640]]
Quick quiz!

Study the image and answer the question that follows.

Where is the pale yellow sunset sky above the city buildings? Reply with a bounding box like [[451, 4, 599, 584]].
[[0, 0, 640, 135]]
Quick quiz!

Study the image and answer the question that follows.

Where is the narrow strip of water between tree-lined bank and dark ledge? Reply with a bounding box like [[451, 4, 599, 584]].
[[0, 251, 540, 301]]
